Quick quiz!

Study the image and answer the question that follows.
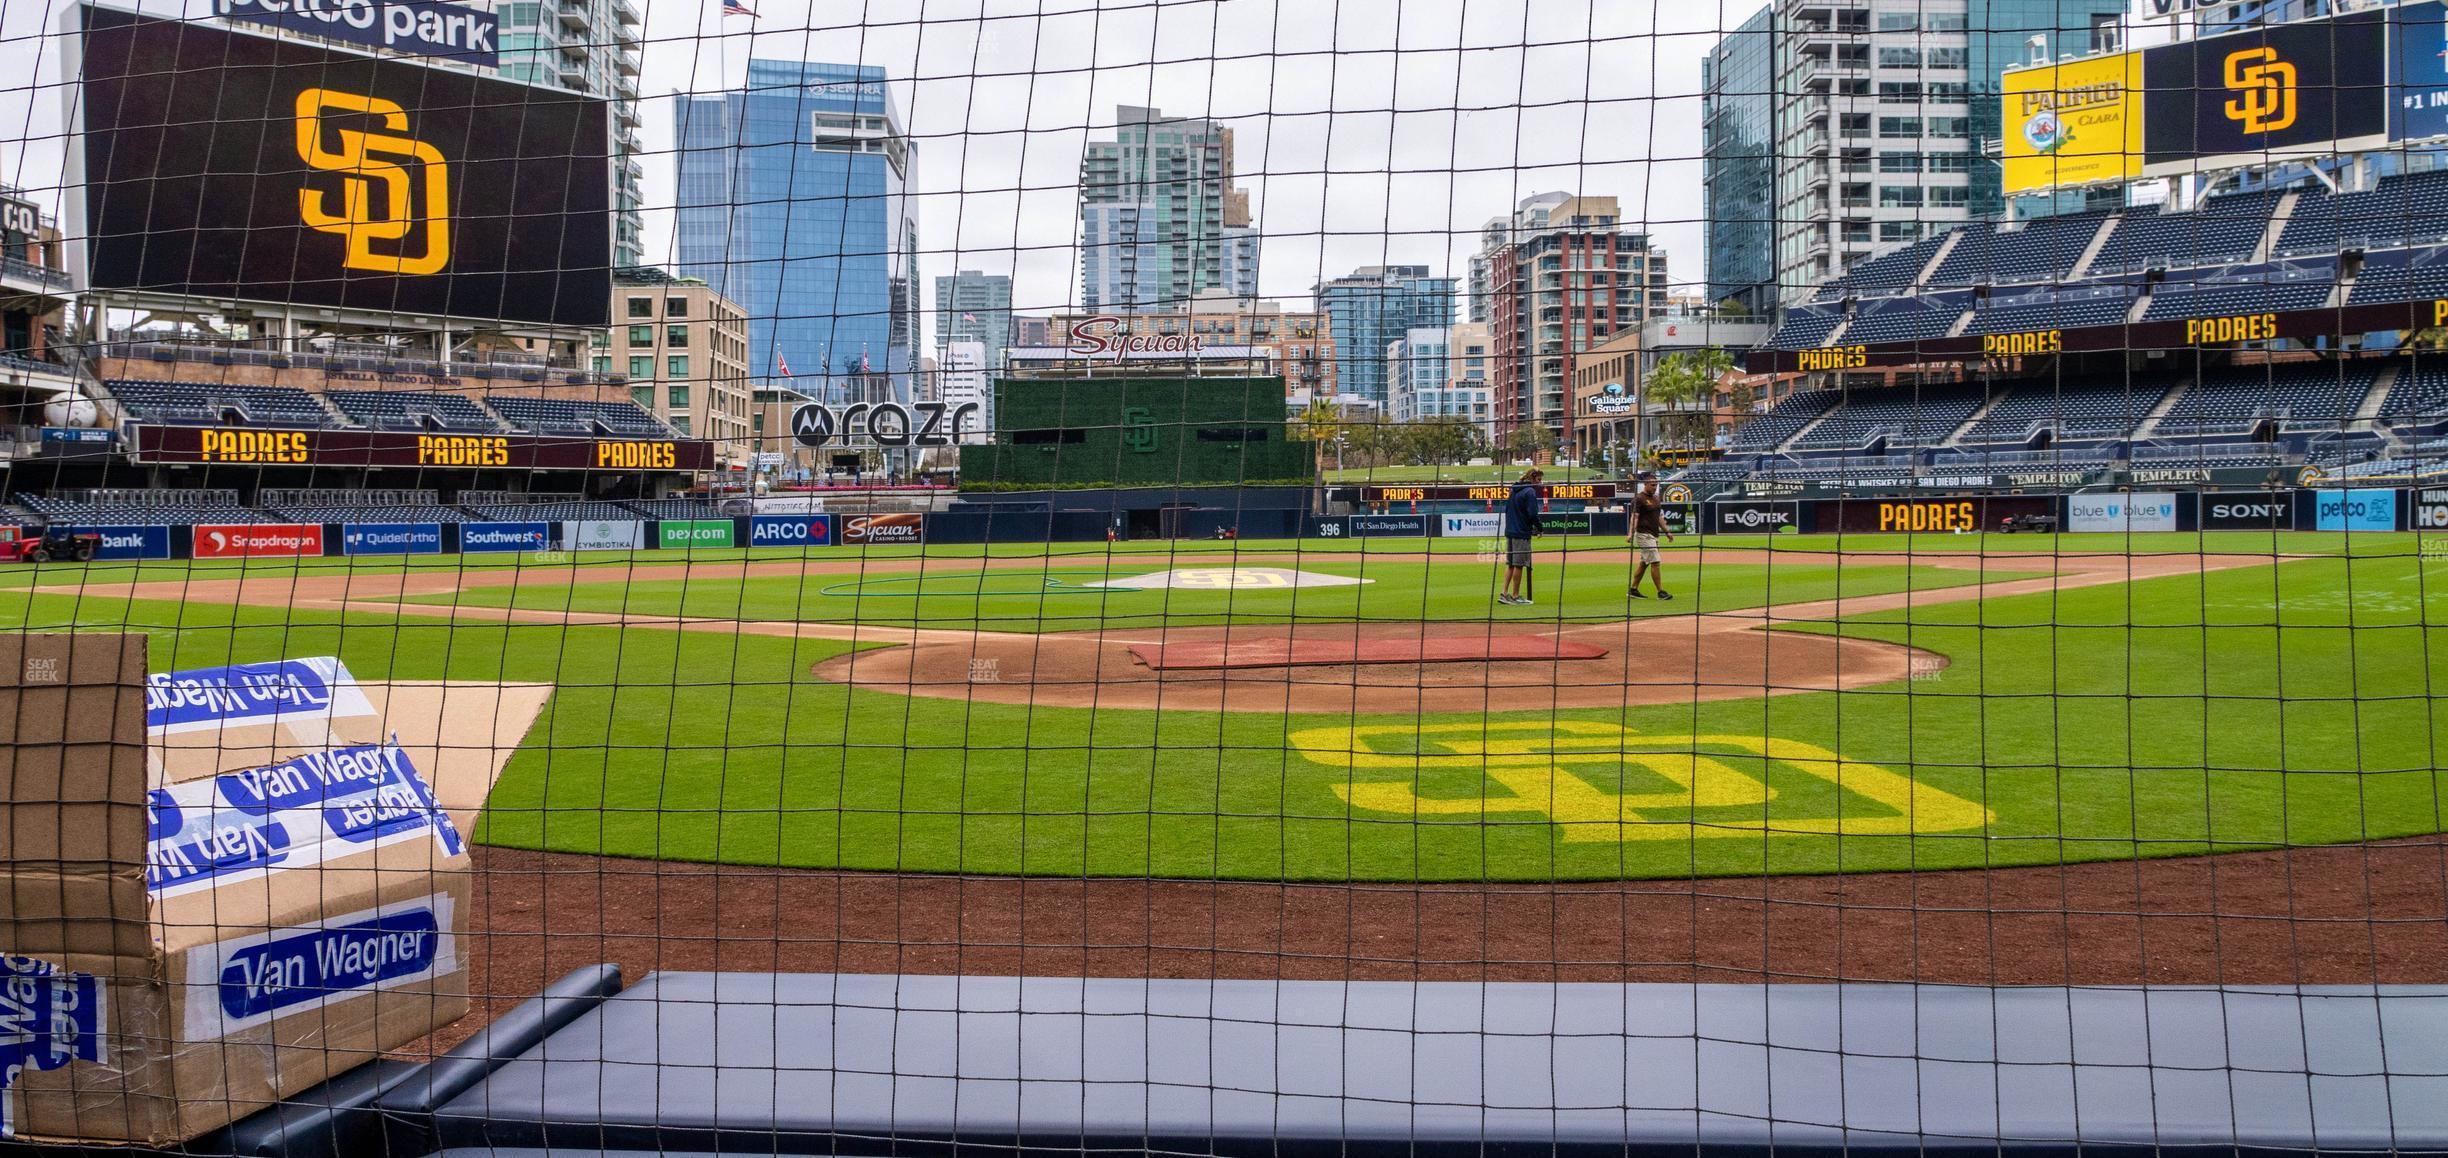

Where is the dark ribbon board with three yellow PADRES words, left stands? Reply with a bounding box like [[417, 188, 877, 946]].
[[132, 426, 715, 470]]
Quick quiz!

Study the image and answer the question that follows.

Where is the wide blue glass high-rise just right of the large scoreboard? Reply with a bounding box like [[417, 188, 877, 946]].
[[676, 59, 920, 404]]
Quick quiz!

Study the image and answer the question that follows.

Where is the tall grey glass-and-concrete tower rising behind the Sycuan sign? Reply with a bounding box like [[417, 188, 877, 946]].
[[1080, 105, 1258, 311]]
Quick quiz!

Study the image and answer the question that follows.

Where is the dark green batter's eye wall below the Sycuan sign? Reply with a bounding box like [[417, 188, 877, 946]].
[[960, 377, 1317, 487]]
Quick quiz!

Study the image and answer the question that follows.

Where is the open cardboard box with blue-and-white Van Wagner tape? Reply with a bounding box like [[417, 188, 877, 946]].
[[0, 634, 551, 1146]]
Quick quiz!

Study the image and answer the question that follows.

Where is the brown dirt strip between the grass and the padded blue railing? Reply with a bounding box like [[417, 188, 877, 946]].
[[435, 837, 2448, 1053]]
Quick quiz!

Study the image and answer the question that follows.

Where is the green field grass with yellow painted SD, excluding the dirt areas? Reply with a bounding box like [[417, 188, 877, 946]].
[[0, 534, 2448, 881]]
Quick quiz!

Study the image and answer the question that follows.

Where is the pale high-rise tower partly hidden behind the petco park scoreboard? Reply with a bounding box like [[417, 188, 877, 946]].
[[492, 0, 646, 267]]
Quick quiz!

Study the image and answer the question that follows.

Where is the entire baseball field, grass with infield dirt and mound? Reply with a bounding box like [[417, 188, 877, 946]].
[[0, 534, 2448, 884]]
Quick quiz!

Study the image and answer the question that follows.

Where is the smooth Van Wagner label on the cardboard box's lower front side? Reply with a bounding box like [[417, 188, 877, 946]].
[[186, 894, 460, 1040]]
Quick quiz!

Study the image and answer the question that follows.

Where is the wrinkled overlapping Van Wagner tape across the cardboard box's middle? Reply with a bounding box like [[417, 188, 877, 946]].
[[144, 744, 468, 896]]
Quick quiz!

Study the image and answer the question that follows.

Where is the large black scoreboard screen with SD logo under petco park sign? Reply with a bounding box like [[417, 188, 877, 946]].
[[71, 0, 612, 326]]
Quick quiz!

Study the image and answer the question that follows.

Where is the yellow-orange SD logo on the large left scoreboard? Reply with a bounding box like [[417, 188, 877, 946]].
[[296, 88, 450, 274]]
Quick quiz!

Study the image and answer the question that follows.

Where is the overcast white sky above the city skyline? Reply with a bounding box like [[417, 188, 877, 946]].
[[0, 0, 1758, 325]]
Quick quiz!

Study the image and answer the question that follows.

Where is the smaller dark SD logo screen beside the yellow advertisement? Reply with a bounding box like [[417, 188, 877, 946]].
[[2142, 10, 2389, 176]]
